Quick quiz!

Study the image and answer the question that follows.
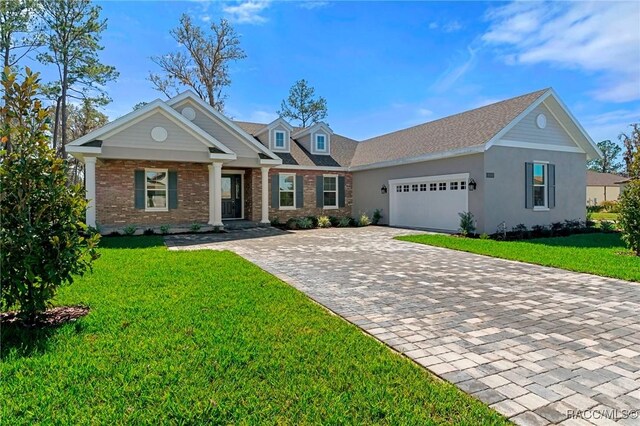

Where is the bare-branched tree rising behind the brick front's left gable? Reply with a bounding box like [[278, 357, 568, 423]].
[[149, 15, 247, 112]]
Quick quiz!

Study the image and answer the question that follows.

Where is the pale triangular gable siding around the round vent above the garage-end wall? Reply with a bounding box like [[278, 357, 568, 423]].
[[501, 104, 577, 147]]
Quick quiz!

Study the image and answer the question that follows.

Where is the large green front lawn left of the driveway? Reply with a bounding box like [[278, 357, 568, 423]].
[[0, 237, 507, 425]]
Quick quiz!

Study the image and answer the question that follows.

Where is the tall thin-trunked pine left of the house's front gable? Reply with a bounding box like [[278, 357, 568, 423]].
[[38, 0, 118, 158]]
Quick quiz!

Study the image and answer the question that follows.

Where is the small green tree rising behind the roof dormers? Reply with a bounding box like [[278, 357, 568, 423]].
[[278, 79, 327, 127]]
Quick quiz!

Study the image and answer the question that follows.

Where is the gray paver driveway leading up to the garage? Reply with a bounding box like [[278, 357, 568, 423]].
[[167, 227, 640, 425]]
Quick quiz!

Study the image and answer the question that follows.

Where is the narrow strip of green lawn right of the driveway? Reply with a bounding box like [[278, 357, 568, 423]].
[[397, 233, 640, 281]]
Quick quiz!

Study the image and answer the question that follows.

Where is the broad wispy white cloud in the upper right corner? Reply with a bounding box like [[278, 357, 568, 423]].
[[482, 2, 640, 102]]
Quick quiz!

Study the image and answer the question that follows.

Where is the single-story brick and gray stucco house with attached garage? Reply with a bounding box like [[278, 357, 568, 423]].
[[67, 89, 600, 232]]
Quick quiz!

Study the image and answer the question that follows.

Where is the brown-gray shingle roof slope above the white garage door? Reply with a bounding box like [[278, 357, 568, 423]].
[[351, 89, 548, 167]]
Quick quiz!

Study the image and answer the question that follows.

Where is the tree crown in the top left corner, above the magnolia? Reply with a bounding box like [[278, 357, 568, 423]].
[[0, 0, 42, 69]]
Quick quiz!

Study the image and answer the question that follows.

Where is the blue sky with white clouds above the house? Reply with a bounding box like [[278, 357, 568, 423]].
[[47, 1, 640, 141]]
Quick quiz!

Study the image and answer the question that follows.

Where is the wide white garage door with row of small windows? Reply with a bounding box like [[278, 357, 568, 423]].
[[389, 173, 469, 232]]
